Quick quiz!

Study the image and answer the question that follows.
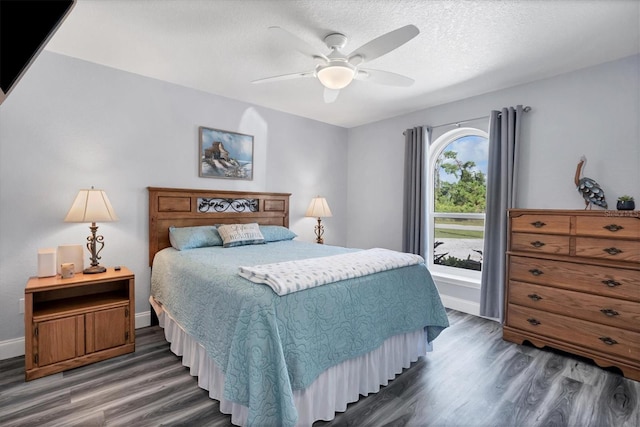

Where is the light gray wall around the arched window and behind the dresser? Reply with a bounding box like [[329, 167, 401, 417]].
[[347, 56, 640, 312]]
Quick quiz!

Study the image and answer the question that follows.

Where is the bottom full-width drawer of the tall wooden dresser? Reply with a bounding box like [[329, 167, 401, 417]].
[[507, 304, 640, 363]]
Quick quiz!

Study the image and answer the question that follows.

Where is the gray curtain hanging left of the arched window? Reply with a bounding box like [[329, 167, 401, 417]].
[[402, 126, 431, 257]]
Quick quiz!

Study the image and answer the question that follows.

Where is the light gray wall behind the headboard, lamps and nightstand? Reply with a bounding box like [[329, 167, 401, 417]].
[[0, 52, 347, 352]]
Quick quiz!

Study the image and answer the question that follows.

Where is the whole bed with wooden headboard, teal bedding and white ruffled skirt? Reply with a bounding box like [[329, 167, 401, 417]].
[[148, 187, 448, 426]]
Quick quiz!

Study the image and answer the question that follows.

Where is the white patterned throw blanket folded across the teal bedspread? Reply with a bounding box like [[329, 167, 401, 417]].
[[240, 248, 424, 295]]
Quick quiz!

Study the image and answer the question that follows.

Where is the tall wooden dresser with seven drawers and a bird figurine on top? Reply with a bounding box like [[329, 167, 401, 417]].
[[503, 209, 640, 381]]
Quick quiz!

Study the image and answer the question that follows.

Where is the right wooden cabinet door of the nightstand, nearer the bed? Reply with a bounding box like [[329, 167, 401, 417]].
[[86, 307, 129, 353]]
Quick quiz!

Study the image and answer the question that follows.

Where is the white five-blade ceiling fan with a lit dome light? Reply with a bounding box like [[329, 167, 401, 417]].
[[251, 25, 420, 103]]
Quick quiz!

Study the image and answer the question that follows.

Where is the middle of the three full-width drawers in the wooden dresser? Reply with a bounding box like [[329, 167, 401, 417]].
[[509, 280, 640, 332]]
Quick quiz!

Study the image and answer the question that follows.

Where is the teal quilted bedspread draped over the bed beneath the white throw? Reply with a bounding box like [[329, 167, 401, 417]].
[[151, 240, 449, 426]]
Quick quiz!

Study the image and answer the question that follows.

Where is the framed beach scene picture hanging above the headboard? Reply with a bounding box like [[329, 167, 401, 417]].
[[199, 126, 253, 181]]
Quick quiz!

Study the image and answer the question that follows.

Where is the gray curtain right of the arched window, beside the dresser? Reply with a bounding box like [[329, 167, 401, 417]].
[[480, 105, 523, 322]]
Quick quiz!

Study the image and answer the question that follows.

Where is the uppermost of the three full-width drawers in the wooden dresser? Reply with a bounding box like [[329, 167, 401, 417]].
[[509, 255, 640, 302]]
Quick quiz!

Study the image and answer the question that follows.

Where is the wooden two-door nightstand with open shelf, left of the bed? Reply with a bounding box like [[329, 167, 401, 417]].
[[24, 267, 135, 381]]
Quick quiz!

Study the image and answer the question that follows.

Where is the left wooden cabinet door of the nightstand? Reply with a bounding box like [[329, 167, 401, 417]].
[[34, 316, 84, 366]]
